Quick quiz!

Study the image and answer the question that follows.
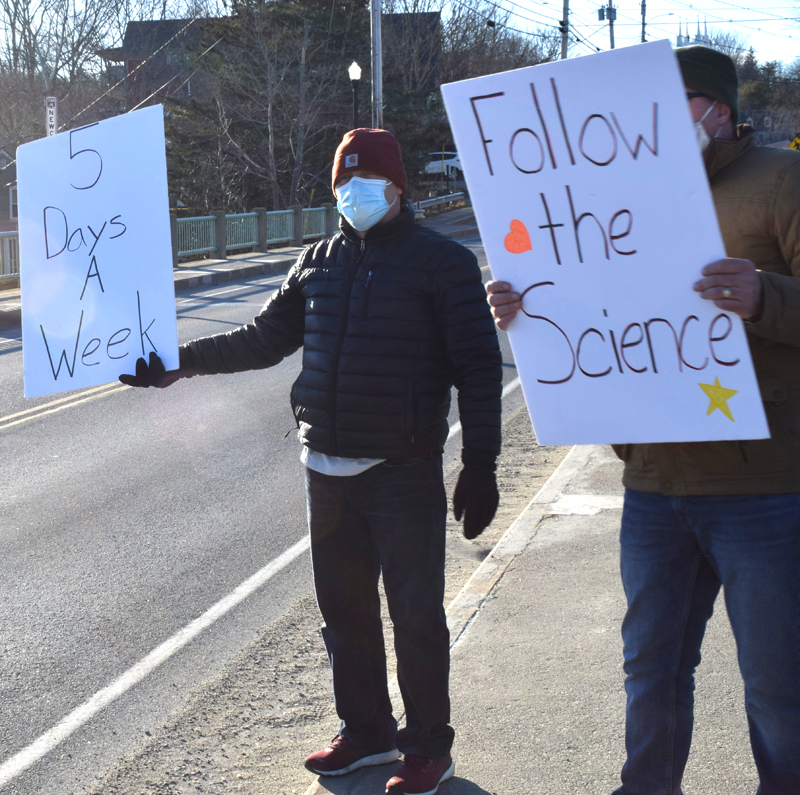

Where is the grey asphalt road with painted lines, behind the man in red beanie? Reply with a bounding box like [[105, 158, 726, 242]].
[[0, 240, 522, 795]]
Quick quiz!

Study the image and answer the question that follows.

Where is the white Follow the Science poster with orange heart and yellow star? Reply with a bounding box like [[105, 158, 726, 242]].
[[442, 41, 769, 444]]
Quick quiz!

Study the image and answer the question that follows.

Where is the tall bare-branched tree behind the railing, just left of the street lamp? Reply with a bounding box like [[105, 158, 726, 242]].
[[173, 3, 344, 209]]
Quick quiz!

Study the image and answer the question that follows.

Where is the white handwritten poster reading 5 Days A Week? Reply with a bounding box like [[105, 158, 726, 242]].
[[17, 106, 178, 398]]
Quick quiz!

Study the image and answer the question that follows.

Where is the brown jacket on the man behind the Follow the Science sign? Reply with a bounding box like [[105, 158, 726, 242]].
[[614, 127, 800, 495]]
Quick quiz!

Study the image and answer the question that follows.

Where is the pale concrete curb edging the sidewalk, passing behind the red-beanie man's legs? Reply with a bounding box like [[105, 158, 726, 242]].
[[304, 446, 597, 795]]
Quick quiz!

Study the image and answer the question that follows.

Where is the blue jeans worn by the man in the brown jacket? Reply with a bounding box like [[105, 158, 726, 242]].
[[616, 489, 800, 795]]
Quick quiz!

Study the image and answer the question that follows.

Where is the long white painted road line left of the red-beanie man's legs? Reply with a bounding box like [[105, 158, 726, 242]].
[[0, 535, 309, 787]]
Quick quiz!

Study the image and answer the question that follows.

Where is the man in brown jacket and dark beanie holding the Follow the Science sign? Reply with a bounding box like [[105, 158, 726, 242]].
[[486, 46, 800, 795]]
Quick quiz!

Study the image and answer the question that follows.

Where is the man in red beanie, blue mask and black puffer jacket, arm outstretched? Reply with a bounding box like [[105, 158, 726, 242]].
[[121, 129, 502, 795]]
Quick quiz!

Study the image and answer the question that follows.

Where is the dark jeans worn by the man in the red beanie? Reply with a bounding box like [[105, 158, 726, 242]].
[[306, 456, 453, 757]]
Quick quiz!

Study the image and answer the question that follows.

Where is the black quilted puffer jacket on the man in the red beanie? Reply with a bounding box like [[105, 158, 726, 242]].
[[181, 204, 502, 460]]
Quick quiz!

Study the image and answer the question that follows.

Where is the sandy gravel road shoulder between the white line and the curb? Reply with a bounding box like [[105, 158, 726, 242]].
[[86, 407, 568, 795]]
